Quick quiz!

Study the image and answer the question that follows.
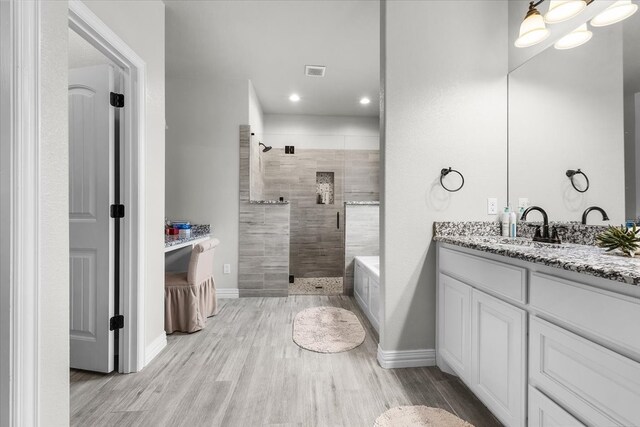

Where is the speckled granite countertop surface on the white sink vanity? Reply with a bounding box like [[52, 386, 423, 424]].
[[434, 235, 640, 286]]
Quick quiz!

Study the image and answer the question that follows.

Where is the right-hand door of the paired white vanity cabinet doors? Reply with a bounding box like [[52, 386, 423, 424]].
[[470, 289, 526, 426]]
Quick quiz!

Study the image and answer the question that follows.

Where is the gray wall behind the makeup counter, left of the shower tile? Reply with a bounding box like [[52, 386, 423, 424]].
[[165, 76, 249, 288]]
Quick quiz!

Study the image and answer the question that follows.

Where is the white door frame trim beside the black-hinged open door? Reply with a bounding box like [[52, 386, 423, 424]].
[[69, 0, 147, 373]]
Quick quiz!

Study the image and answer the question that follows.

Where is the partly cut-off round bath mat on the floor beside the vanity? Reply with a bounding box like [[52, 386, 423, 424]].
[[373, 406, 473, 427]]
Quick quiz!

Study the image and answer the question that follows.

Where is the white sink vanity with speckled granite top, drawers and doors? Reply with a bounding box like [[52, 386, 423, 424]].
[[435, 229, 640, 426]]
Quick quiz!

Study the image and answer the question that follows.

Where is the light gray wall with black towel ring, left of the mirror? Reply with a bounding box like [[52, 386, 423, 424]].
[[380, 0, 508, 358]]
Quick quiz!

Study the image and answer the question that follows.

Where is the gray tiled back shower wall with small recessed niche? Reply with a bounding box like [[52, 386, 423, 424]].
[[261, 148, 380, 277]]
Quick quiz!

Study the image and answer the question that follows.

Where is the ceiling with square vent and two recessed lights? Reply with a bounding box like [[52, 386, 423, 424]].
[[165, 0, 380, 116]]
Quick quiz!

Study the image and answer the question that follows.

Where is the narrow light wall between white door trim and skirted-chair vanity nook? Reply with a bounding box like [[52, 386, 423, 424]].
[[85, 0, 165, 354]]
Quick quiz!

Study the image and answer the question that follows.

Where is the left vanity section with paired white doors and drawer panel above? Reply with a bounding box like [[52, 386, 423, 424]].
[[438, 250, 527, 426]]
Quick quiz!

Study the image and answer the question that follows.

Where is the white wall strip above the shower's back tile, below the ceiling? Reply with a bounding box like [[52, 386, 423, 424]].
[[263, 114, 380, 150]]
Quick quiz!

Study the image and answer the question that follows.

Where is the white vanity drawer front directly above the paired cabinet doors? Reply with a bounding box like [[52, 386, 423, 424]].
[[439, 248, 527, 304]]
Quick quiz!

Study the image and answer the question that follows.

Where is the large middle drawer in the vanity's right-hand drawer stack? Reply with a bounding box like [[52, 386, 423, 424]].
[[529, 316, 640, 426]]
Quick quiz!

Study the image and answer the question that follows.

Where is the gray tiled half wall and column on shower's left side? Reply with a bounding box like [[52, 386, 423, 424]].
[[238, 125, 290, 297]]
